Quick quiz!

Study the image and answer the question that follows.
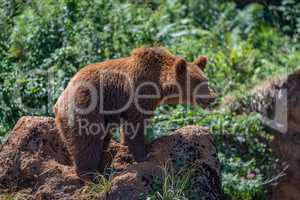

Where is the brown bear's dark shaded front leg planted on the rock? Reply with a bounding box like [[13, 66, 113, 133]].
[[121, 121, 147, 162]]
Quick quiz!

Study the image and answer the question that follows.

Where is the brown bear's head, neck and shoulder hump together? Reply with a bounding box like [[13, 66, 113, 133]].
[[132, 47, 216, 107]]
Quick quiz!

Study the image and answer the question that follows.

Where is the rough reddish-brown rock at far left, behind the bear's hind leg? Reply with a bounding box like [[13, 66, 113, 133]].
[[0, 117, 83, 199]]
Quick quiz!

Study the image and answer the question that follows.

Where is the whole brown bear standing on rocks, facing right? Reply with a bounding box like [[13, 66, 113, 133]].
[[53, 47, 215, 177]]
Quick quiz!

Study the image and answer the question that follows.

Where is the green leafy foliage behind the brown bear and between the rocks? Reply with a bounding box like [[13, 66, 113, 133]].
[[0, 0, 300, 199]]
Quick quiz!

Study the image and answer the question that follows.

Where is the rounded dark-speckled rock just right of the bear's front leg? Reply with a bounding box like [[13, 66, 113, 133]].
[[108, 126, 221, 200]]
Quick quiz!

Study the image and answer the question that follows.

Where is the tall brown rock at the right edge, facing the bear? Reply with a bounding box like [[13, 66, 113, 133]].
[[222, 70, 300, 200]]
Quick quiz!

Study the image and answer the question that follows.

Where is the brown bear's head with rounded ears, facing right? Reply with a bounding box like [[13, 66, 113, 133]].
[[162, 56, 216, 107]]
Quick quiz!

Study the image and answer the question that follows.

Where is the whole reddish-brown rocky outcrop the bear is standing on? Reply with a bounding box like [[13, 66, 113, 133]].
[[0, 117, 221, 200]]
